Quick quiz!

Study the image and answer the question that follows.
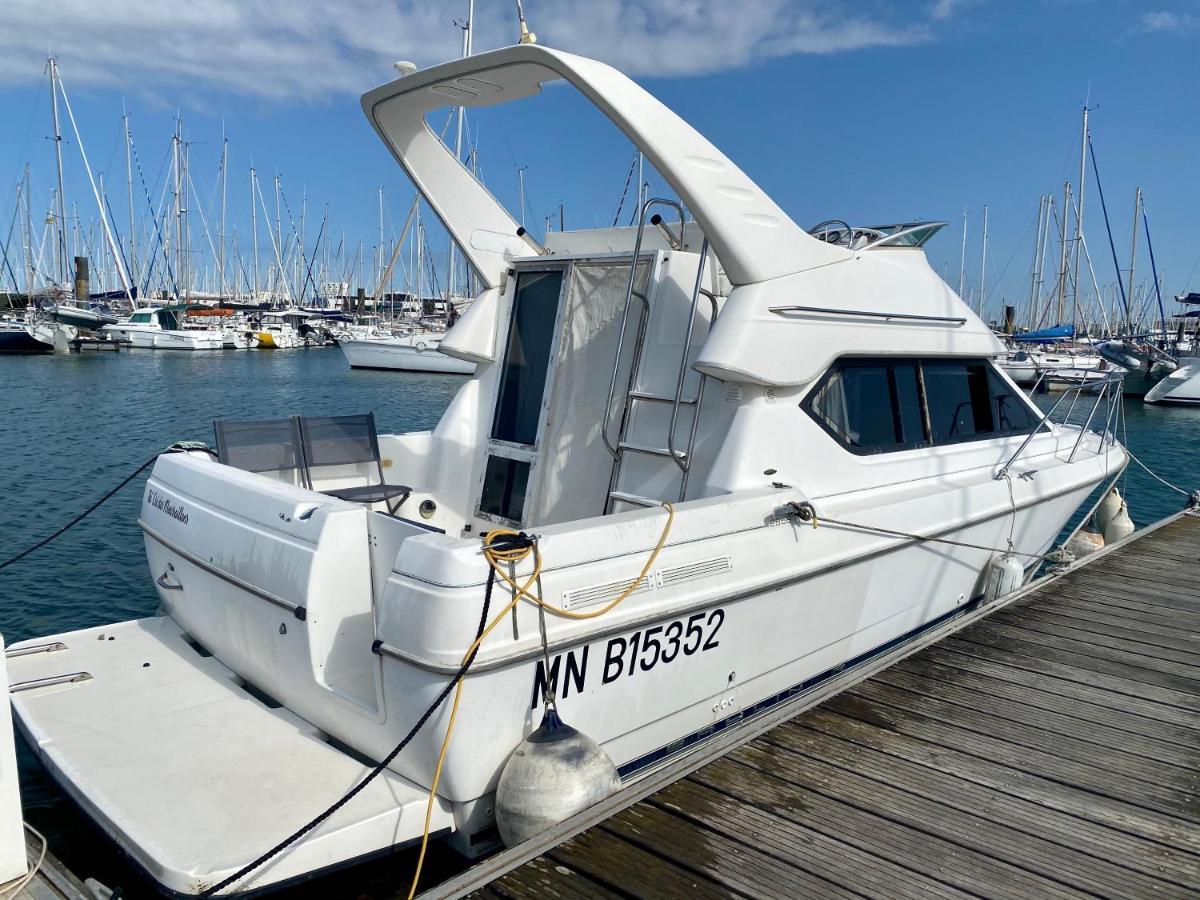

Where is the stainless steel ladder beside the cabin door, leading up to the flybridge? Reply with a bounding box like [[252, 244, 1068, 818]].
[[600, 197, 718, 512]]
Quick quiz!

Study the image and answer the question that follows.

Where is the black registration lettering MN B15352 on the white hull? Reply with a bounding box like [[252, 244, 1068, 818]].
[[529, 610, 725, 709]]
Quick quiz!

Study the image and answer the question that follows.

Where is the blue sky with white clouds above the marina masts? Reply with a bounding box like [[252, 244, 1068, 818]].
[[0, 0, 1200, 324]]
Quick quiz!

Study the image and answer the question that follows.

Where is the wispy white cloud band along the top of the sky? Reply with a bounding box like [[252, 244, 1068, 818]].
[[0, 0, 936, 100]]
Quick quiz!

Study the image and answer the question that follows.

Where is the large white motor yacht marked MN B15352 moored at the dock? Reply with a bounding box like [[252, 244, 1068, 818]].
[[8, 44, 1127, 895]]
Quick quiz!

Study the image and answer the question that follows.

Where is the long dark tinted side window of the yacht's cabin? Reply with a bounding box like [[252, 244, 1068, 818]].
[[800, 359, 1039, 455]]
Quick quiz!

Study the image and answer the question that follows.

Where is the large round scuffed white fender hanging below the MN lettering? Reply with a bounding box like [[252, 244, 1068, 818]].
[[496, 707, 620, 847]]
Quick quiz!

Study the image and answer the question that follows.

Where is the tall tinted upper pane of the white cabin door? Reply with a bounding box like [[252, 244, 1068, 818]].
[[492, 271, 563, 445]]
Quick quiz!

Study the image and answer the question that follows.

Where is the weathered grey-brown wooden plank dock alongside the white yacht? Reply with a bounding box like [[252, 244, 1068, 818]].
[[428, 514, 1200, 899]]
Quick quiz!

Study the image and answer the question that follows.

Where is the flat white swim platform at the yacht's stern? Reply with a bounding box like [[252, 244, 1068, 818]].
[[8, 617, 450, 894]]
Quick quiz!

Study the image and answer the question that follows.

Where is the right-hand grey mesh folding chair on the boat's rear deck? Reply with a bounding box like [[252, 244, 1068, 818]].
[[300, 413, 413, 514]]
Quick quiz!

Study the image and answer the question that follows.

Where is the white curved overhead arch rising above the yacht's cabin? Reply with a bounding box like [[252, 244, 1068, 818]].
[[362, 44, 847, 286]]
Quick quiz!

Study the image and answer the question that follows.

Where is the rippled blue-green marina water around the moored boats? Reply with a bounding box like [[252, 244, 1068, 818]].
[[0, 349, 1200, 898]]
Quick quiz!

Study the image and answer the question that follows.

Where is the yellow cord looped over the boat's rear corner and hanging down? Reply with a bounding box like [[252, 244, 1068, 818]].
[[408, 500, 674, 900]]
